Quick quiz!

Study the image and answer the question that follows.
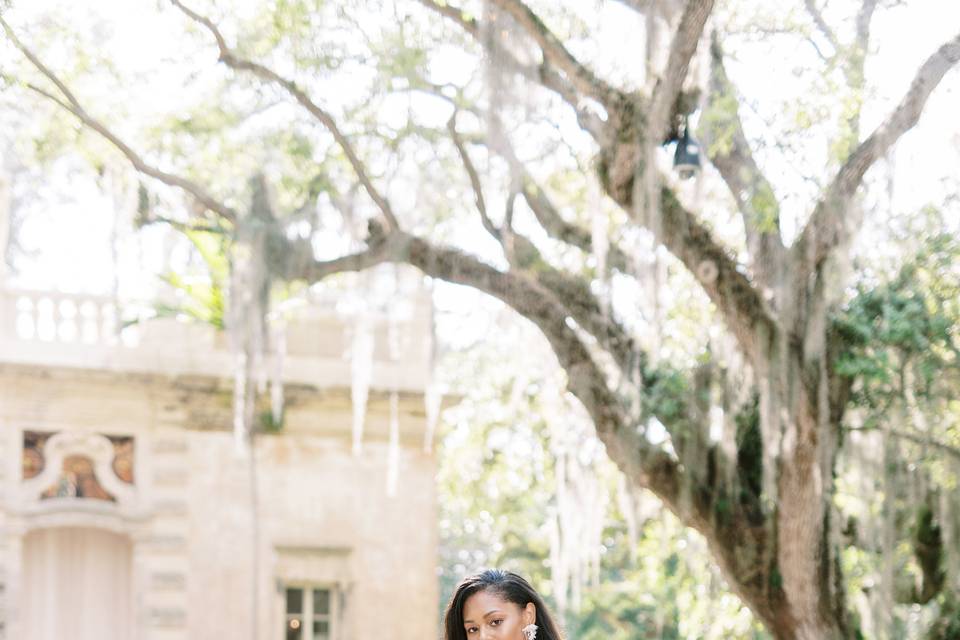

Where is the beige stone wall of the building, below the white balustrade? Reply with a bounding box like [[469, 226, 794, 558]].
[[0, 354, 437, 640]]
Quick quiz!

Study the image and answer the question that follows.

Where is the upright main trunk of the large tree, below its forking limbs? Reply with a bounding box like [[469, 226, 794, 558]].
[[728, 274, 851, 640]]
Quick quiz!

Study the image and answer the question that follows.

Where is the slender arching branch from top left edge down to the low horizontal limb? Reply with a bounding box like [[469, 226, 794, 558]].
[[170, 0, 400, 230]]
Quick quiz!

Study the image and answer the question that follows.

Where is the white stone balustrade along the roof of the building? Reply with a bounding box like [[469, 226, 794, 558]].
[[0, 288, 432, 391]]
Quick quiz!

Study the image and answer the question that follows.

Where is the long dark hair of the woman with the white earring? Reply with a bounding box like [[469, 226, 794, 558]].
[[443, 569, 563, 640]]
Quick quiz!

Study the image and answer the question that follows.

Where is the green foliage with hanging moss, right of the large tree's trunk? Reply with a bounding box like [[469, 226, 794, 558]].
[[832, 220, 960, 637]]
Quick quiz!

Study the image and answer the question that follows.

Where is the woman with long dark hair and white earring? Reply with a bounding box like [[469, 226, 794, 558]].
[[443, 569, 562, 640]]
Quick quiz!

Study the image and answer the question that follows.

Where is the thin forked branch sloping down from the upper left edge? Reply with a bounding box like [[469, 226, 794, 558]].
[[0, 16, 236, 221]]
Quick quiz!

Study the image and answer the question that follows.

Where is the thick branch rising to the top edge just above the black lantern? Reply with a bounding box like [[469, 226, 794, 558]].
[[646, 0, 714, 145]]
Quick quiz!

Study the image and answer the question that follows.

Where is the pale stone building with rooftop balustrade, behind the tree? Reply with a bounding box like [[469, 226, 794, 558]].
[[0, 262, 438, 640]]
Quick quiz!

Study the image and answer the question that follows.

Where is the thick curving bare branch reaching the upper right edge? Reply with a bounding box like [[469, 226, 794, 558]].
[[791, 34, 960, 281]]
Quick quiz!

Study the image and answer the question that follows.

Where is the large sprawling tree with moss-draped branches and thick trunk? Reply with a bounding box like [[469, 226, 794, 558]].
[[0, 0, 960, 639]]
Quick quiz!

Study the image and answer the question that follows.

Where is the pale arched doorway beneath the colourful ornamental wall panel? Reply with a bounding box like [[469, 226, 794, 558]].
[[23, 527, 133, 640]]
